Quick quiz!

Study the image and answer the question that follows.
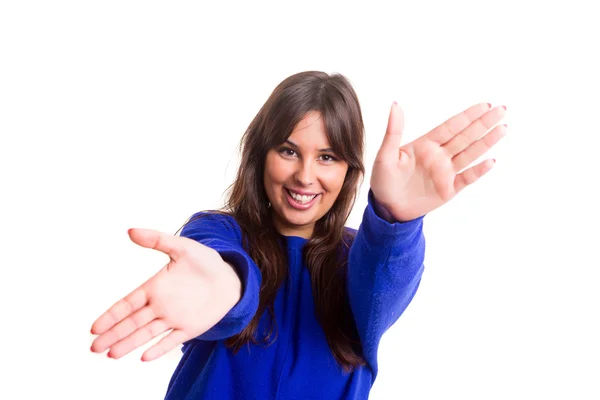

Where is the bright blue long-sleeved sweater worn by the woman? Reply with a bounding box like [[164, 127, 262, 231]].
[[166, 192, 425, 400]]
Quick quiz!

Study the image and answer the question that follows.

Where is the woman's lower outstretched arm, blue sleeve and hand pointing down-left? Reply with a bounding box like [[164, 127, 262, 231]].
[[91, 215, 261, 361]]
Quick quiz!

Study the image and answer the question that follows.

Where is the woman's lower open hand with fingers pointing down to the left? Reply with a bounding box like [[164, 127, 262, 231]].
[[91, 229, 241, 361]]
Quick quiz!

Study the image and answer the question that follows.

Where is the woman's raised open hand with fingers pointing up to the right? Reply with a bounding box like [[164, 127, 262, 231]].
[[371, 103, 506, 221]]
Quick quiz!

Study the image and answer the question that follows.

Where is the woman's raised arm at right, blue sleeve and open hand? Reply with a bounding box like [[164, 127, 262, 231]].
[[348, 103, 506, 373]]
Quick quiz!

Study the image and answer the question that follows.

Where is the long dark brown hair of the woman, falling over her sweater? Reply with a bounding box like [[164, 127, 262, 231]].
[[179, 71, 365, 371]]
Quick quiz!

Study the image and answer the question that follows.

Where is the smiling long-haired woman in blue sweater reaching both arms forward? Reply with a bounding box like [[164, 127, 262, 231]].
[[92, 71, 505, 399]]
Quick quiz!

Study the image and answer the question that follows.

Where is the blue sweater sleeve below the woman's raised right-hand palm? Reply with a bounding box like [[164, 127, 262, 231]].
[[348, 191, 425, 380]]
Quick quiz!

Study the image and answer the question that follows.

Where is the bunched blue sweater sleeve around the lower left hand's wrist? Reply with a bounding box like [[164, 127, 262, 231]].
[[180, 213, 261, 340]]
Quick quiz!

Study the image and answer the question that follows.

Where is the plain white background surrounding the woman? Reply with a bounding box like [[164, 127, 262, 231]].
[[0, 1, 600, 400]]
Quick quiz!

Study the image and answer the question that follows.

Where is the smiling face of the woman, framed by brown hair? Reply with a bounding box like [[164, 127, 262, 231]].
[[264, 111, 348, 238]]
